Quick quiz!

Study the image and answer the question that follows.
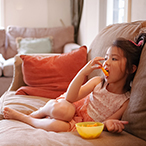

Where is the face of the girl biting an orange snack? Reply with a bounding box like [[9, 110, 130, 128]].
[[103, 47, 128, 83]]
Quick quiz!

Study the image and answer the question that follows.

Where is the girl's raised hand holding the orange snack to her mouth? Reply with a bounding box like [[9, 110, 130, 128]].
[[81, 57, 104, 76]]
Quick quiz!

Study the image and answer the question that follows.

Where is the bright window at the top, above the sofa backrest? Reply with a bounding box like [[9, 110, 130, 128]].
[[106, 0, 130, 25]]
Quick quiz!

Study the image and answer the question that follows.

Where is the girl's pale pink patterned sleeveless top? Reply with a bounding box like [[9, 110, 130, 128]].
[[87, 83, 130, 122]]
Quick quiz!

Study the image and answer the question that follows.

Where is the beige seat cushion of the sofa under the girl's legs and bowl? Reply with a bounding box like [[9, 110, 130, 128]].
[[0, 91, 146, 146]]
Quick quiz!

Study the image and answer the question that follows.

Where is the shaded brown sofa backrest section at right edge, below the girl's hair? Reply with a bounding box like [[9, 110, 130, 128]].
[[123, 45, 146, 140]]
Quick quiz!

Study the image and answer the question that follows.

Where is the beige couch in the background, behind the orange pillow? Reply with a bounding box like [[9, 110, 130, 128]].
[[0, 26, 78, 96]]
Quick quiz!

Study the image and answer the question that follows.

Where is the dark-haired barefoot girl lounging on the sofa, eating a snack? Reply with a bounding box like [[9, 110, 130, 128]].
[[3, 33, 146, 133]]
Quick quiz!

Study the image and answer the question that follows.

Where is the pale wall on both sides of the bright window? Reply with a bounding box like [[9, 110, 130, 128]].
[[78, 0, 146, 48]]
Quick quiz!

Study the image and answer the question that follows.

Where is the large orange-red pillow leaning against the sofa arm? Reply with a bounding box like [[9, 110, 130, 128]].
[[16, 46, 87, 98]]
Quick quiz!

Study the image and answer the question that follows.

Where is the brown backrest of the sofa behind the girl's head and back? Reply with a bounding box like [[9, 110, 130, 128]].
[[88, 21, 146, 140]]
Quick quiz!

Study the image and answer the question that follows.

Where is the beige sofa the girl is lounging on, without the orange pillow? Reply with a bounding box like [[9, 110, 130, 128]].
[[0, 21, 146, 146]]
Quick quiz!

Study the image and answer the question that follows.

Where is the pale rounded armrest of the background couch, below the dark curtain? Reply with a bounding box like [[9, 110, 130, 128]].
[[63, 43, 80, 53]]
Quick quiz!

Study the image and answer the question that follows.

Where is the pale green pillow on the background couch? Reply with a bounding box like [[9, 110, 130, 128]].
[[16, 37, 53, 54]]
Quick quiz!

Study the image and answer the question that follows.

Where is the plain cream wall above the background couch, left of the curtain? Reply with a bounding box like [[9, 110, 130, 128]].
[[3, 0, 71, 28]]
